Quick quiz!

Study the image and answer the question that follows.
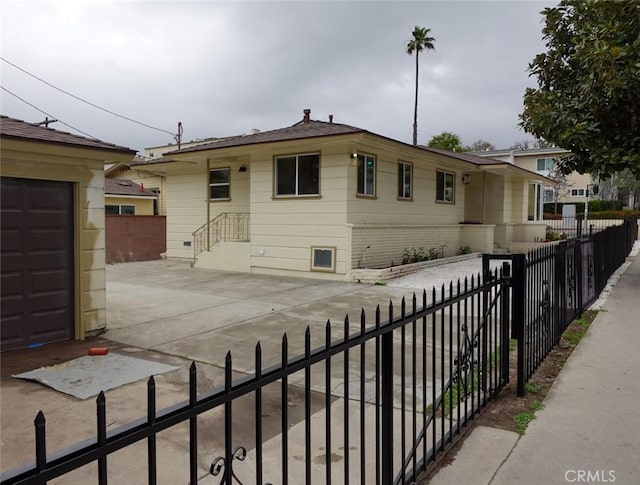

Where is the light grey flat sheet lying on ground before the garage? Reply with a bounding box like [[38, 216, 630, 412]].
[[11, 354, 178, 399]]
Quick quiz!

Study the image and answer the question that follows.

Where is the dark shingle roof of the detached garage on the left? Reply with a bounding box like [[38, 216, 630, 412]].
[[0, 115, 136, 154]]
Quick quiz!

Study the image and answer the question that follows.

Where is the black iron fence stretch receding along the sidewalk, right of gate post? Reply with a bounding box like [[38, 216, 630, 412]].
[[509, 219, 638, 395]]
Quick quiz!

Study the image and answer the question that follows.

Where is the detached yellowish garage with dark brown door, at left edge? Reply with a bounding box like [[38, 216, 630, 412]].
[[0, 116, 135, 351]]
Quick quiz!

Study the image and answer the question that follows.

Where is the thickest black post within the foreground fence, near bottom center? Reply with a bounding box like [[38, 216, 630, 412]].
[[382, 310, 392, 484]]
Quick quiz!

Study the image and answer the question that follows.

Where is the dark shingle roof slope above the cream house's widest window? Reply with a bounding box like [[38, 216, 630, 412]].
[[165, 120, 366, 154]]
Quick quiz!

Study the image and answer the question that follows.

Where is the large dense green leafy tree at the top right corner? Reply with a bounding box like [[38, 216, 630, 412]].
[[520, 0, 640, 176]]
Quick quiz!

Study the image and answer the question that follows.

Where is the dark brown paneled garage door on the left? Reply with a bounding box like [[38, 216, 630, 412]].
[[0, 177, 74, 351]]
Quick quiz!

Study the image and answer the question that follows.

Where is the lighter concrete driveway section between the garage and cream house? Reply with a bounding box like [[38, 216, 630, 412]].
[[104, 261, 420, 372]]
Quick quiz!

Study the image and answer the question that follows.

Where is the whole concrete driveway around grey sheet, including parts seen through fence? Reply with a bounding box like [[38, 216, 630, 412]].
[[0, 260, 460, 484]]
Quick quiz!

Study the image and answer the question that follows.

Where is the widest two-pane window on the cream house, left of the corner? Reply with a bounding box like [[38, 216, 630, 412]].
[[275, 153, 320, 197]]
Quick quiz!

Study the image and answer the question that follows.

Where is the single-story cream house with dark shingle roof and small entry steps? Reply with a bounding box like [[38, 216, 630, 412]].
[[144, 110, 550, 280]]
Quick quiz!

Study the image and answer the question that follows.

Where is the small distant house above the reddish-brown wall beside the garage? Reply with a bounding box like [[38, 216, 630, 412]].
[[104, 178, 158, 216]]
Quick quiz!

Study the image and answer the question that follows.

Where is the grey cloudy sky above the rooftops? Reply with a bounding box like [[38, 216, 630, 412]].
[[0, 0, 557, 150]]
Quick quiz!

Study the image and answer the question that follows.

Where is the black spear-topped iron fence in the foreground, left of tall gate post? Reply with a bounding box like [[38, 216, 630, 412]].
[[2, 272, 509, 484]]
